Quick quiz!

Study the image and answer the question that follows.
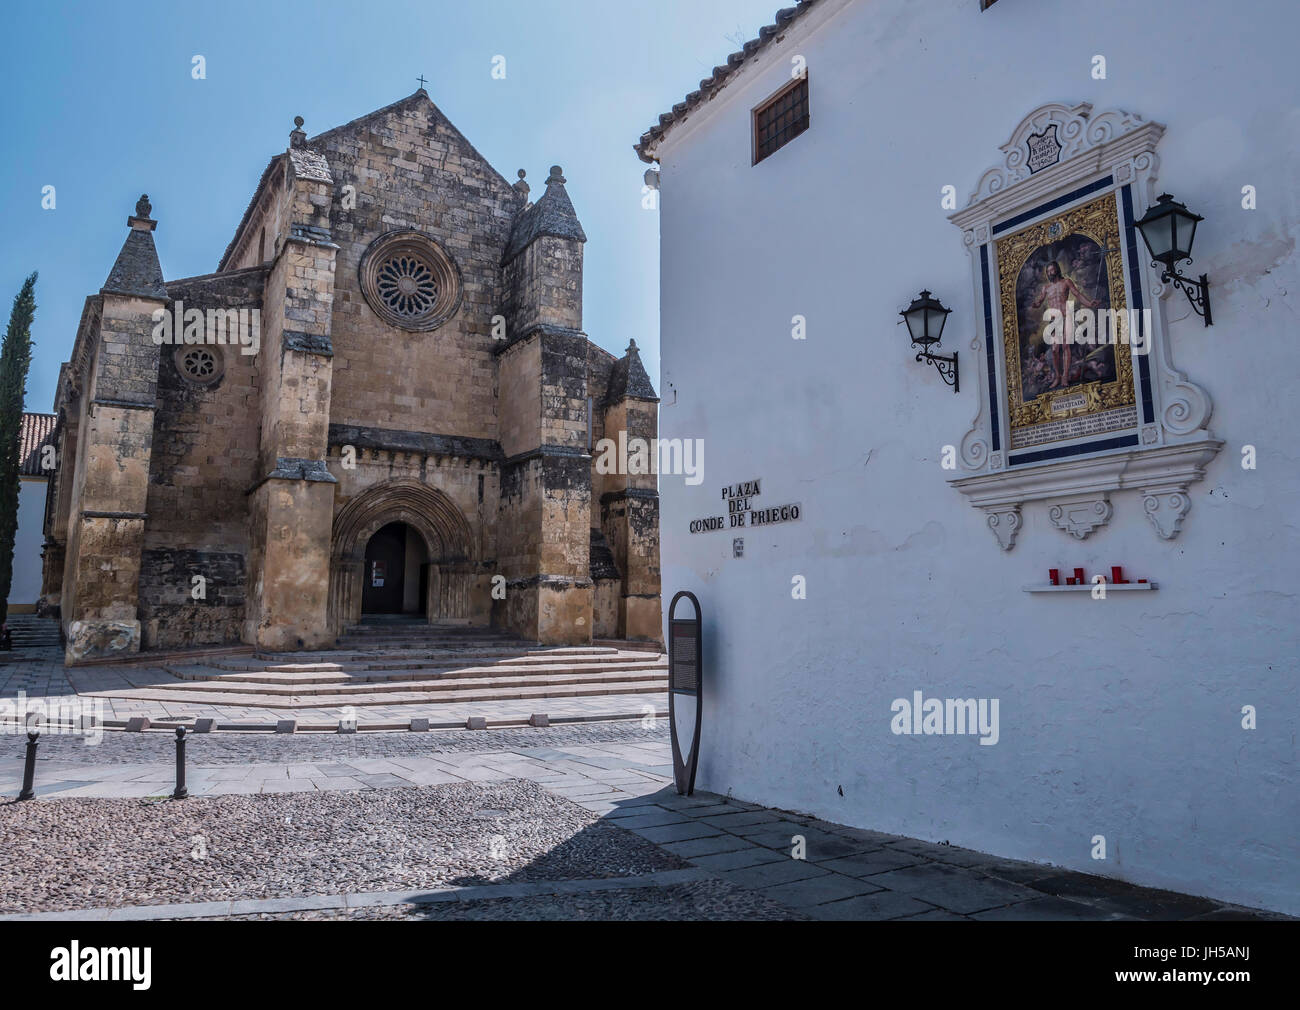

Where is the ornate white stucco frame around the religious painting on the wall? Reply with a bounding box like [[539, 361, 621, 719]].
[[949, 103, 1223, 551]]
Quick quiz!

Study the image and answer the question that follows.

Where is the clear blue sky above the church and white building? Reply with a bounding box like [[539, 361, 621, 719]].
[[0, 0, 781, 411]]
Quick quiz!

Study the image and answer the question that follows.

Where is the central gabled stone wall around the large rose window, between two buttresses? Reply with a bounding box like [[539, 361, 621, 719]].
[[312, 99, 520, 439]]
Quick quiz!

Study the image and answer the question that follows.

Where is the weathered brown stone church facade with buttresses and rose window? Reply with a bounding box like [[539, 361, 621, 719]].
[[42, 88, 662, 662]]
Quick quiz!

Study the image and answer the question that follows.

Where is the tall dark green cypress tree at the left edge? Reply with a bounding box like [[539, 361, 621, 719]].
[[0, 273, 36, 624]]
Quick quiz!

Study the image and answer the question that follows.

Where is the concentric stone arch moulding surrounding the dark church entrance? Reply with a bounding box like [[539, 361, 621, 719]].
[[329, 481, 490, 634]]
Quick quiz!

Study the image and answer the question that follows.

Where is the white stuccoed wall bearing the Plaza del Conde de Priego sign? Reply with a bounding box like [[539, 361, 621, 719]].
[[660, 0, 1300, 913]]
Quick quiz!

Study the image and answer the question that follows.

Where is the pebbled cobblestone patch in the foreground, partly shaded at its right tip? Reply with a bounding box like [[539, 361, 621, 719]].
[[0, 779, 689, 913]]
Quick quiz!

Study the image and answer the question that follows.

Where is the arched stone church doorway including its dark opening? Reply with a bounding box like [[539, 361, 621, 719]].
[[329, 481, 489, 634]]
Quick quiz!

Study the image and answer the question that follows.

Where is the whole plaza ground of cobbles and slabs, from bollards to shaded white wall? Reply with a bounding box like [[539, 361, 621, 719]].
[[0, 720, 1284, 920]]
